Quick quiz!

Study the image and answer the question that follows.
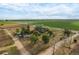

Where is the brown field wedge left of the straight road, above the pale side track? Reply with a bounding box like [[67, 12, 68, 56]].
[[0, 30, 14, 48]]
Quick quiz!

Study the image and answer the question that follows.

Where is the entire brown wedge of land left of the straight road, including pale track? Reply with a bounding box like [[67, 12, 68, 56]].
[[0, 29, 19, 55]]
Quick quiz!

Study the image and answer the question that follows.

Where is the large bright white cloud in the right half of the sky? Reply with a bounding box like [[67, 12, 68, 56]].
[[34, 5, 74, 15]]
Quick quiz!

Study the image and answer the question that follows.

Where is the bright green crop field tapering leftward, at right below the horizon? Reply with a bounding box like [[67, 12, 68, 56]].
[[31, 21, 79, 30]]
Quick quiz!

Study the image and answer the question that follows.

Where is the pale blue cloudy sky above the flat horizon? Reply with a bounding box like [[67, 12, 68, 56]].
[[0, 3, 79, 19]]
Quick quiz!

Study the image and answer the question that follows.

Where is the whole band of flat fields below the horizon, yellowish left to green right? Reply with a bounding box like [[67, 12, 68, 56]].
[[0, 20, 79, 30]]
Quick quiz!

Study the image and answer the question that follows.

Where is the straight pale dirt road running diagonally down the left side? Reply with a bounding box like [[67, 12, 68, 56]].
[[4, 29, 30, 55]]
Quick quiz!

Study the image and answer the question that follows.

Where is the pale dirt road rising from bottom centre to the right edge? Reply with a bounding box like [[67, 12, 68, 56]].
[[38, 33, 79, 55]]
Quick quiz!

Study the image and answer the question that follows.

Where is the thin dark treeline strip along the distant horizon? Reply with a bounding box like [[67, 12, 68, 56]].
[[0, 19, 79, 21]]
